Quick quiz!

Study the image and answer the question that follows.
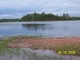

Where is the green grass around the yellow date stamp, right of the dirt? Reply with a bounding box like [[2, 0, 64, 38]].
[[55, 43, 80, 56]]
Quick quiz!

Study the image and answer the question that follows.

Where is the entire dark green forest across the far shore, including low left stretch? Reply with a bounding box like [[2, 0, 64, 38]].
[[0, 12, 80, 22]]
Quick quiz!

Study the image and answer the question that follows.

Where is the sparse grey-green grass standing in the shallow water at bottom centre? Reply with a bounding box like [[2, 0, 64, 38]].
[[23, 49, 54, 60]]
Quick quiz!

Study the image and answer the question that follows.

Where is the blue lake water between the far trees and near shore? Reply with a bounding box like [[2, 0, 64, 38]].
[[0, 21, 80, 37]]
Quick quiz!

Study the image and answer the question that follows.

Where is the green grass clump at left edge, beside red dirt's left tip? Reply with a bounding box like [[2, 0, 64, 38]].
[[0, 37, 20, 55]]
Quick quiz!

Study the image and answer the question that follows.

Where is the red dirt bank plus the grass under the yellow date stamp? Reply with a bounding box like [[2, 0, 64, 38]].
[[8, 37, 80, 55]]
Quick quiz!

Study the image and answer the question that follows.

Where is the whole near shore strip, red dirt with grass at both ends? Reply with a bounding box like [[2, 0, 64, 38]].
[[0, 36, 80, 56]]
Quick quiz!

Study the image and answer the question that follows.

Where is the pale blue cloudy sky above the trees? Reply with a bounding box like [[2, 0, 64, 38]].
[[0, 0, 80, 19]]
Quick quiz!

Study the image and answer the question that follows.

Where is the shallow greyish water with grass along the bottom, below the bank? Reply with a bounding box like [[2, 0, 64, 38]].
[[0, 48, 80, 60]]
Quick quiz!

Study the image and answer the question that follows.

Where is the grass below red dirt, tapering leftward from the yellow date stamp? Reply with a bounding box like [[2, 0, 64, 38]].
[[31, 43, 80, 56]]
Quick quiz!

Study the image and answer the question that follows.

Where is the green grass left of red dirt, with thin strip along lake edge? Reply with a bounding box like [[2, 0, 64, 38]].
[[0, 36, 40, 55]]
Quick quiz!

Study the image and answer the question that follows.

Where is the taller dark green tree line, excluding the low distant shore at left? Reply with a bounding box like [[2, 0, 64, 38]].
[[21, 12, 80, 21]]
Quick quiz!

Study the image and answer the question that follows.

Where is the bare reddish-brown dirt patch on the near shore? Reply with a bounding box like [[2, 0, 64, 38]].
[[8, 37, 80, 48]]
